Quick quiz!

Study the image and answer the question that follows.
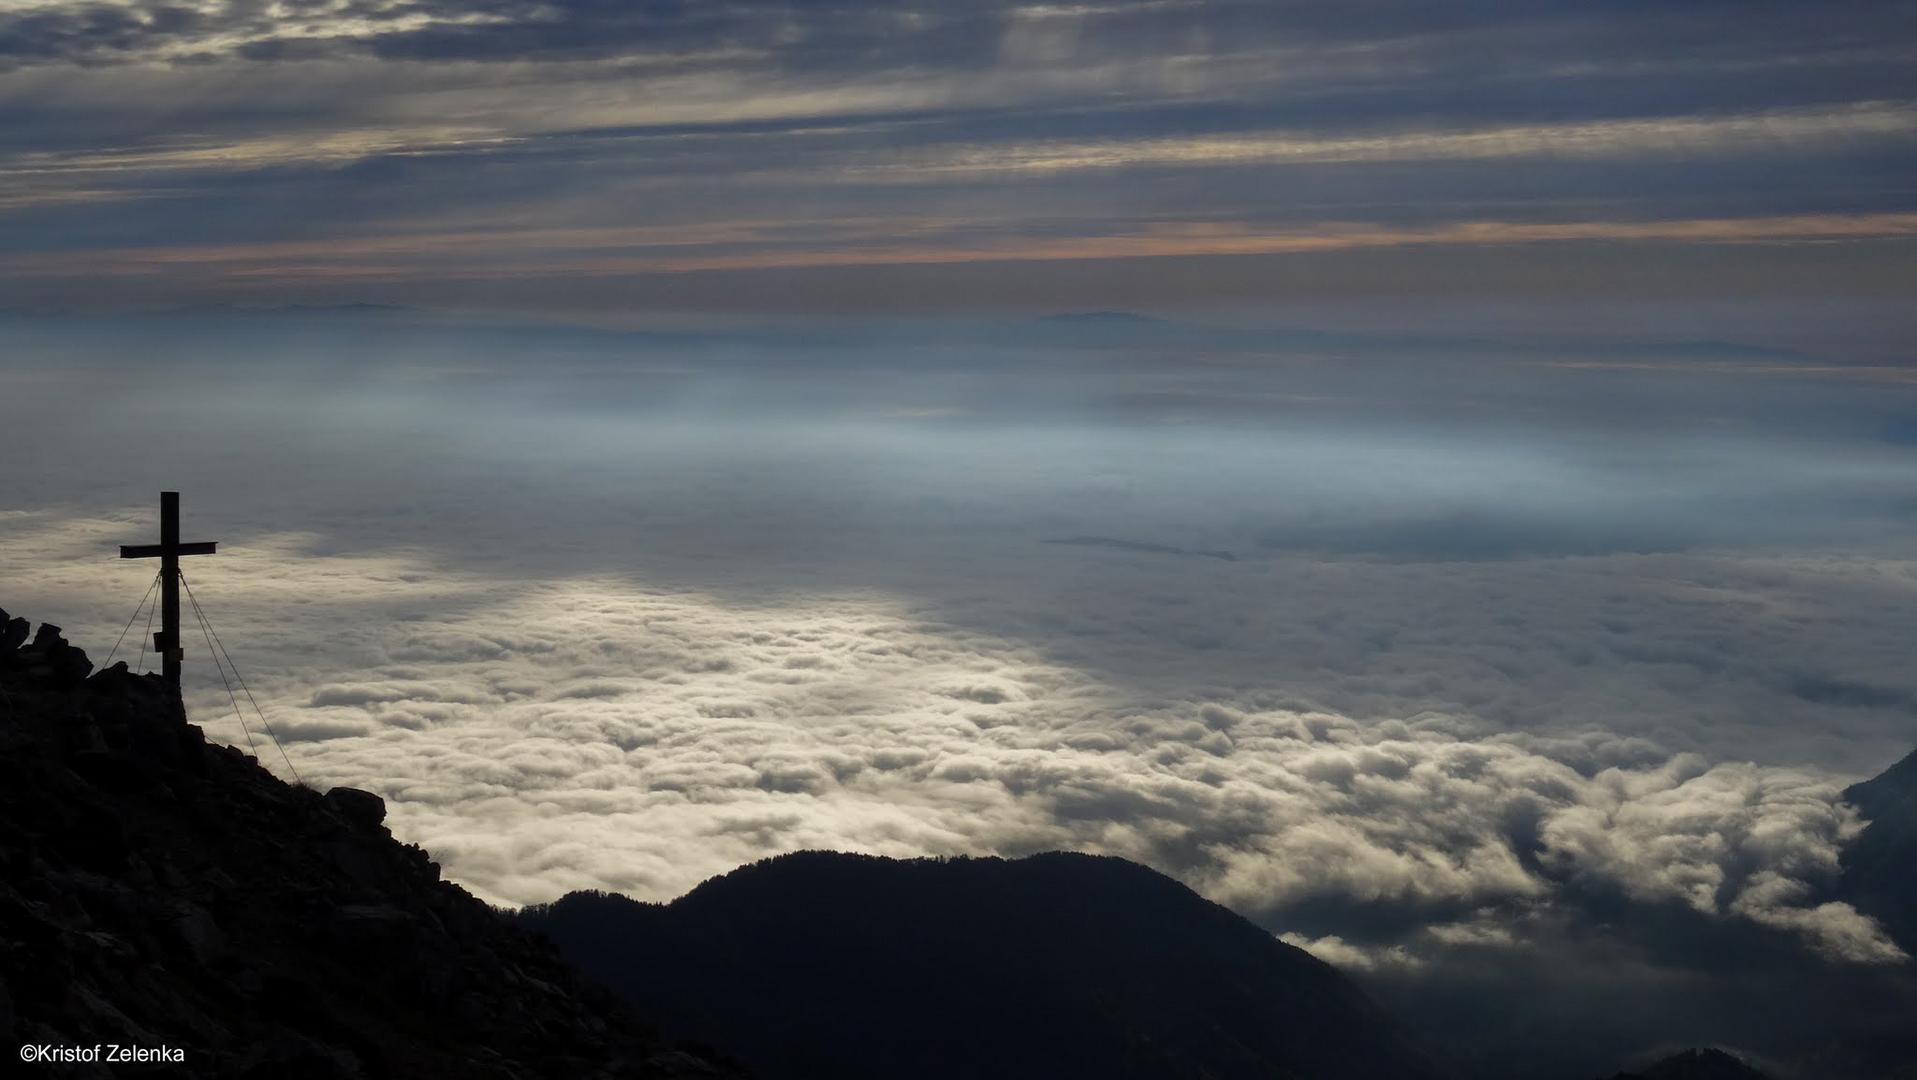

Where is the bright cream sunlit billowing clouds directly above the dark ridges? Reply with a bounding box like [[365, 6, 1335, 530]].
[[14, 526, 1902, 963]]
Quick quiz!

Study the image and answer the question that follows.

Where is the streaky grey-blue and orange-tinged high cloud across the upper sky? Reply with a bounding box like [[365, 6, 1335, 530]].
[[0, 2, 1917, 307]]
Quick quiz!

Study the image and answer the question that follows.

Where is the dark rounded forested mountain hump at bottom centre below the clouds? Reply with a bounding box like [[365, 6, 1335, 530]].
[[520, 852, 1436, 1080]]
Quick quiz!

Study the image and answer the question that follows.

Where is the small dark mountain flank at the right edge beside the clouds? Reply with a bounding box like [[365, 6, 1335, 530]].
[[1840, 752, 1917, 955]]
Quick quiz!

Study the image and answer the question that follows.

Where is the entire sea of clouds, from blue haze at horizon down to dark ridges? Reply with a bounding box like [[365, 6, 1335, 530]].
[[0, 312, 1917, 969]]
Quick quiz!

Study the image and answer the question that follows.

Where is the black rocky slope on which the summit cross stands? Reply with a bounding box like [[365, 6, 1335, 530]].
[[0, 612, 734, 1080]]
